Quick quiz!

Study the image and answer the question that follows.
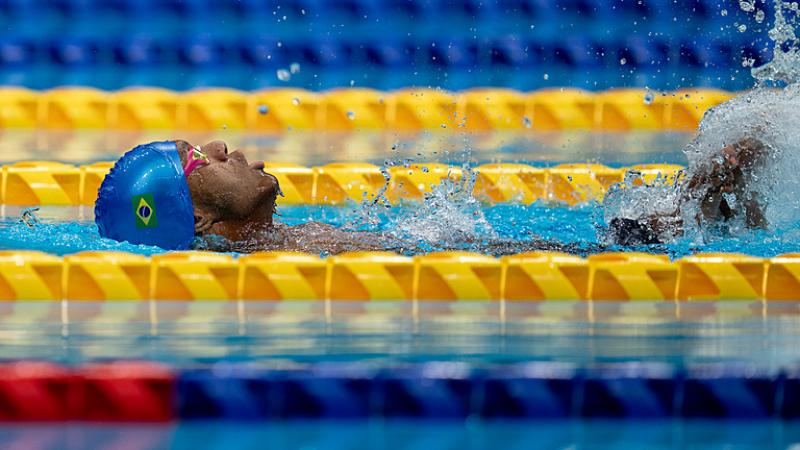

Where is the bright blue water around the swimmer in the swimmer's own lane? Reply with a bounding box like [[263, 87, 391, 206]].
[[0, 203, 800, 257]]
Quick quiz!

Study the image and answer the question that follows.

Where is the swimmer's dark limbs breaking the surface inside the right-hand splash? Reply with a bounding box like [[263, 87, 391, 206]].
[[609, 137, 769, 245]]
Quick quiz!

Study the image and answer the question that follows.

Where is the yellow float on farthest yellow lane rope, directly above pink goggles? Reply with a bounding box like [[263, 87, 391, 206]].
[[177, 89, 248, 131]]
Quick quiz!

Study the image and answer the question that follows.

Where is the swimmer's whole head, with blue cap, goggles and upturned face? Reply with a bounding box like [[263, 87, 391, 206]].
[[95, 141, 280, 250]]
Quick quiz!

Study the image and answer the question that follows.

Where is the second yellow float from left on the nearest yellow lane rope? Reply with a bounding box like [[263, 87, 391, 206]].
[[64, 251, 150, 300]]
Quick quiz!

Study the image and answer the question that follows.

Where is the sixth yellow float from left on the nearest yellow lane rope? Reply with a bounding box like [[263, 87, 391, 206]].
[[414, 252, 502, 300]]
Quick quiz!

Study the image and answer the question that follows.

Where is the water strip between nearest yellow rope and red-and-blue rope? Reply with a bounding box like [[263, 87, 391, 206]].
[[0, 301, 800, 371]]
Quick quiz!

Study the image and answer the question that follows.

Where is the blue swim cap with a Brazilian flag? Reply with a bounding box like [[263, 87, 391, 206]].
[[94, 141, 194, 250]]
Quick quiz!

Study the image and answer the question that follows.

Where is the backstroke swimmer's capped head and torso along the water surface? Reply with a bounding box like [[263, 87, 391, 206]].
[[95, 140, 591, 254]]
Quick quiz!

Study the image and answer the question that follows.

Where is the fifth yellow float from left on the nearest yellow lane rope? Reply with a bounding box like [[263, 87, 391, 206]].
[[328, 252, 414, 300]]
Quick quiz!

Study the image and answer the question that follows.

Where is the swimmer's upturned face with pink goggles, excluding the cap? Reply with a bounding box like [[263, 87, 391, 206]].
[[177, 141, 280, 232]]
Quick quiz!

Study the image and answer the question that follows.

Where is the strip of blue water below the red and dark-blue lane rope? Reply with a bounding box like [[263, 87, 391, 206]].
[[0, 420, 800, 450]]
